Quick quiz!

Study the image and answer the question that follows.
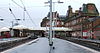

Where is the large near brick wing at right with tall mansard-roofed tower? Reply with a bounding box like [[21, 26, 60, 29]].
[[64, 3, 100, 38]]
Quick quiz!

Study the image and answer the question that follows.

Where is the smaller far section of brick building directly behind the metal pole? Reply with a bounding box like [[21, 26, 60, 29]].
[[41, 12, 66, 27]]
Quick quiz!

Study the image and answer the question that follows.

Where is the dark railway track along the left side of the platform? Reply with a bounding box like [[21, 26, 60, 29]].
[[0, 38, 33, 52]]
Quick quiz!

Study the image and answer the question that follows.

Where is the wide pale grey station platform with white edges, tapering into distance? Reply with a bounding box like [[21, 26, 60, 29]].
[[1, 37, 100, 53]]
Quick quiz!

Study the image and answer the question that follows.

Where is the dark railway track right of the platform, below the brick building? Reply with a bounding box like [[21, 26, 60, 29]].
[[66, 38, 100, 51]]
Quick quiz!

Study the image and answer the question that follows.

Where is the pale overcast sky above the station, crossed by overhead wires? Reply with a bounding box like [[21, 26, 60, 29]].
[[0, 0, 100, 27]]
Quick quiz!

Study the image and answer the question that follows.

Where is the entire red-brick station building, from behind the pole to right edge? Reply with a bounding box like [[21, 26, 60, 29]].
[[41, 3, 100, 39]]
